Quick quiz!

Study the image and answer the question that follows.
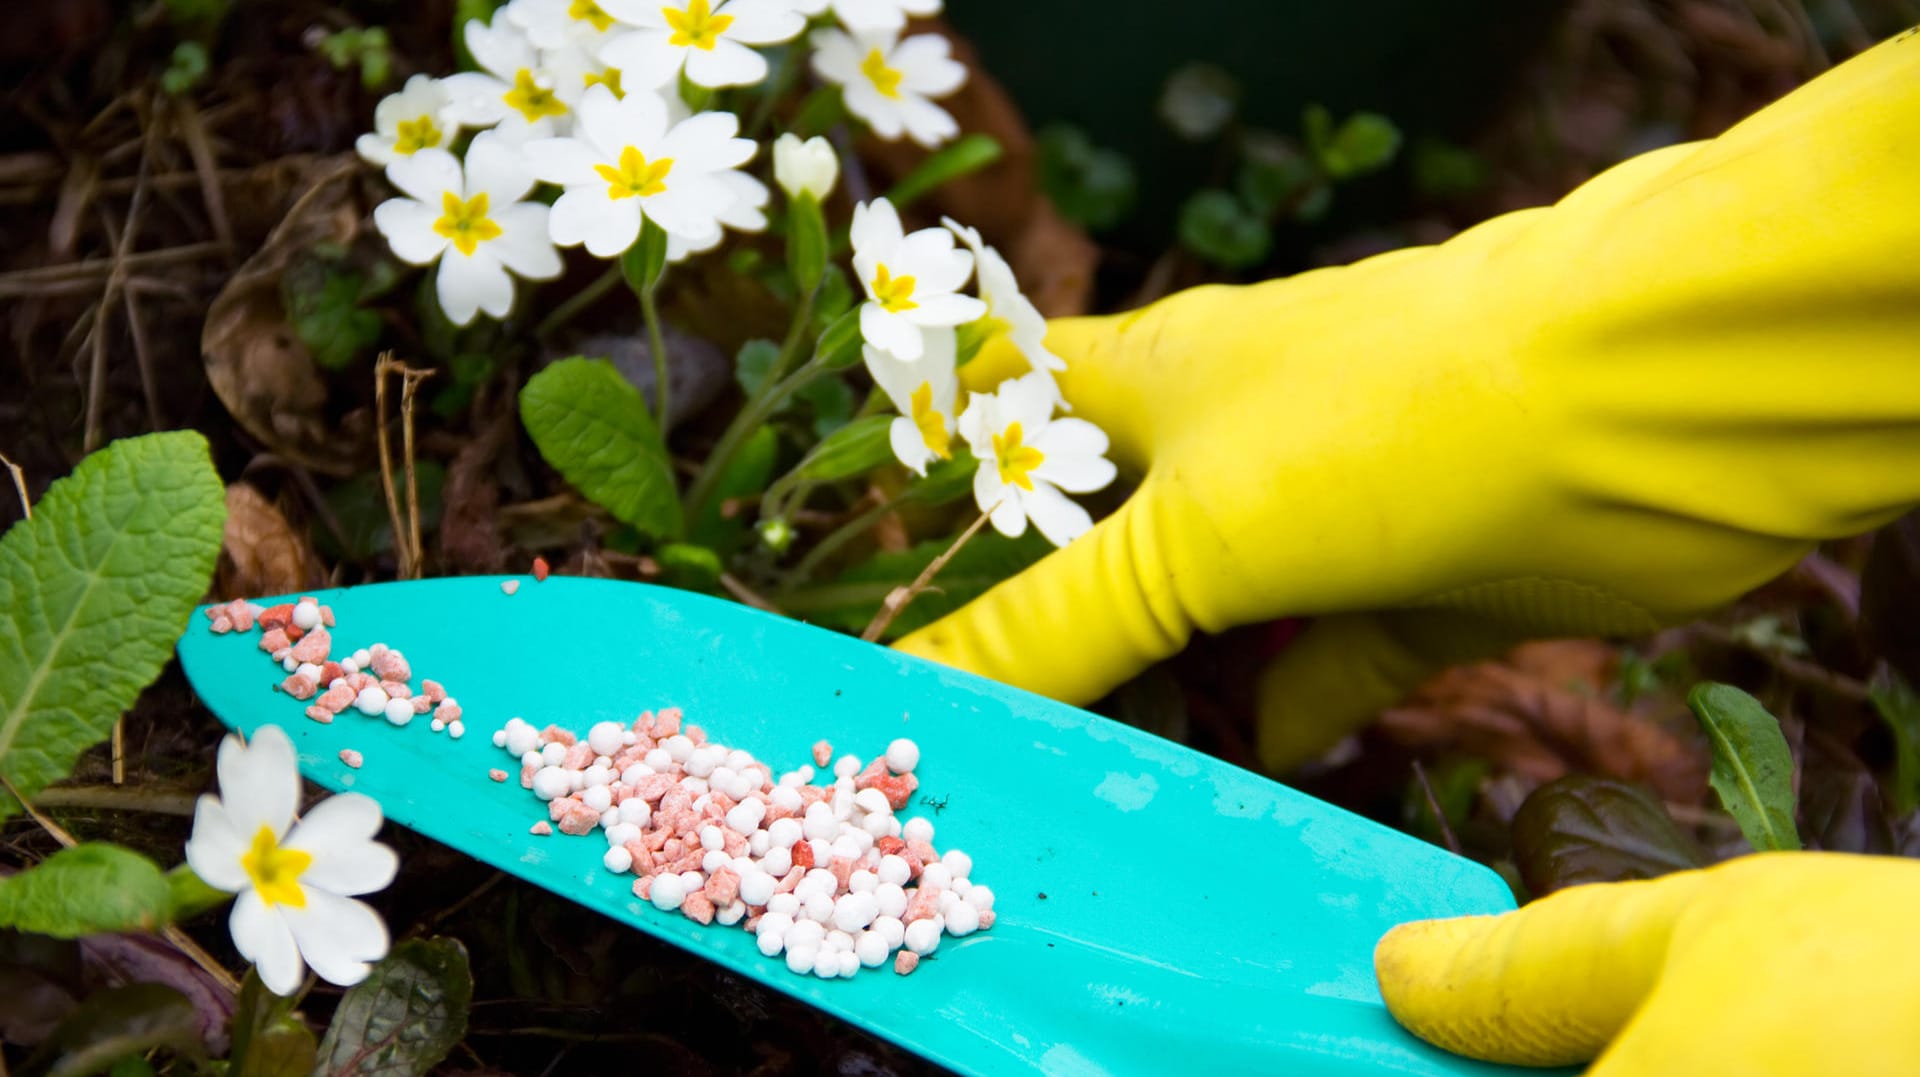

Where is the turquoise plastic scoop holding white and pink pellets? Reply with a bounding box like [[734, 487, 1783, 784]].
[[180, 576, 1513, 1075]]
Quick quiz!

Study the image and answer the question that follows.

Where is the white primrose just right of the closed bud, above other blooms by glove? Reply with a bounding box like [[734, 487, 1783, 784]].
[[851, 198, 987, 363]]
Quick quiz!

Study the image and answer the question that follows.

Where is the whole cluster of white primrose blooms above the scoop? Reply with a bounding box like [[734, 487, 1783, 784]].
[[359, 0, 1114, 545]]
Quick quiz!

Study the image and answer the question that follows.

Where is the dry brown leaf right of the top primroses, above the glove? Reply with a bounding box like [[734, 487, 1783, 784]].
[[860, 23, 1100, 319]]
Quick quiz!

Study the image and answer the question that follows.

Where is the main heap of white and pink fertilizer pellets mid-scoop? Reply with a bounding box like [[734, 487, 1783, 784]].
[[493, 710, 995, 979]]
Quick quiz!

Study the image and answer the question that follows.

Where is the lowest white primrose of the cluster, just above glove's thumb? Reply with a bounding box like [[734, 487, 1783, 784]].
[[960, 374, 1116, 545]]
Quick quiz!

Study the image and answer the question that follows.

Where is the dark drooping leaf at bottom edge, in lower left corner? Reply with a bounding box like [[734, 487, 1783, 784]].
[[21, 983, 202, 1077]]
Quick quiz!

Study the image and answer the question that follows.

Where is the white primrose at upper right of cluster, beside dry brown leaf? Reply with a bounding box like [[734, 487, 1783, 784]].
[[814, 29, 966, 150]]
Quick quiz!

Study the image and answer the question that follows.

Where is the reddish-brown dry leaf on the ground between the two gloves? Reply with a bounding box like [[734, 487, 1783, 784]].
[[1380, 639, 1707, 802]]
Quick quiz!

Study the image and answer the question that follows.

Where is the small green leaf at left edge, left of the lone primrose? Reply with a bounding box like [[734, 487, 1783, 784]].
[[0, 841, 171, 939]]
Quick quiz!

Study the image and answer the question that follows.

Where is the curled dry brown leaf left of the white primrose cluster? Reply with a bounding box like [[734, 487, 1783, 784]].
[[200, 154, 372, 476]]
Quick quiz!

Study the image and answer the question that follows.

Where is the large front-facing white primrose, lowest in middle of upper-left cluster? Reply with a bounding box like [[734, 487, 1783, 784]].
[[526, 86, 755, 257]]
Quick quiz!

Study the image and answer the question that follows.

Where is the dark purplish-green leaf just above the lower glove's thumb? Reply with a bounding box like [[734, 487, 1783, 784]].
[[1513, 774, 1701, 897]]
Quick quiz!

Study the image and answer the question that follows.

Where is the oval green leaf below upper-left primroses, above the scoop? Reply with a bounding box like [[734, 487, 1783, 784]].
[[520, 355, 682, 536]]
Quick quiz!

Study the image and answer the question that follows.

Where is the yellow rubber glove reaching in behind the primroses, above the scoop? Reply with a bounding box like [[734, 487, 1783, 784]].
[[900, 36, 1920, 770]]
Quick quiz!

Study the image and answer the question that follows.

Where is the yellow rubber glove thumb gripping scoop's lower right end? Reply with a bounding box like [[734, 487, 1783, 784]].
[[1373, 852, 1920, 1077]]
